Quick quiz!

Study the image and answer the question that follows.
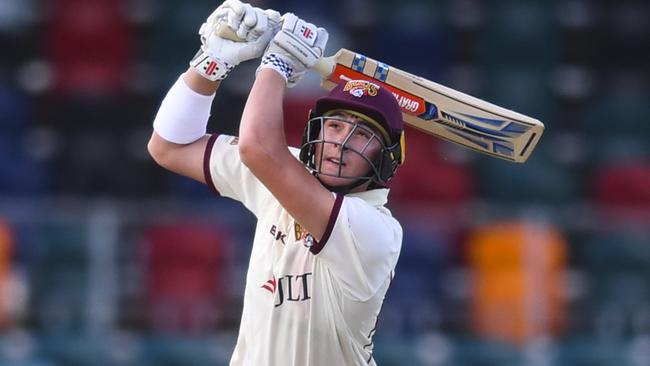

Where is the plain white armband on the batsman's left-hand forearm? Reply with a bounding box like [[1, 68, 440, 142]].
[[153, 75, 214, 144]]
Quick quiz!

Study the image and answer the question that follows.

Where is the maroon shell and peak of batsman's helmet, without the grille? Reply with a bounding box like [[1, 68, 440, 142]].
[[313, 80, 404, 145]]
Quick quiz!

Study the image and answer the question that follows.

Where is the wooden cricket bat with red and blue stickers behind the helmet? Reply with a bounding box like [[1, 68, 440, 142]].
[[314, 49, 544, 163]]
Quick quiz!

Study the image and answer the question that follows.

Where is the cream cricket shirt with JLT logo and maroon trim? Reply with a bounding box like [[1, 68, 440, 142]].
[[204, 135, 402, 366]]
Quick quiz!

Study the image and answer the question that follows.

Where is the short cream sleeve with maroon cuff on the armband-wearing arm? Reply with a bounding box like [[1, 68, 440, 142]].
[[203, 135, 274, 216]]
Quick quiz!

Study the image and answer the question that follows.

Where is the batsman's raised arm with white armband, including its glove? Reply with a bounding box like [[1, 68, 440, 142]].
[[147, 0, 280, 183]]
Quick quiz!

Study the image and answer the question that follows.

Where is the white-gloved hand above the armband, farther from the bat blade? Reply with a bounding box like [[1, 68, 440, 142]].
[[190, 0, 281, 80]]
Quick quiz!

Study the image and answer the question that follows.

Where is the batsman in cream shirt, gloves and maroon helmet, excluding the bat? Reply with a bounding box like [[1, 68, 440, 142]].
[[148, 0, 404, 366]]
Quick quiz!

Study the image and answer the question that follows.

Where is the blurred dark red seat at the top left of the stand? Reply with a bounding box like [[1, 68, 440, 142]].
[[45, 0, 132, 95]]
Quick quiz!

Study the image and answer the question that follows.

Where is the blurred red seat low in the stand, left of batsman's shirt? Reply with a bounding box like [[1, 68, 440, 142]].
[[143, 223, 231, 332]]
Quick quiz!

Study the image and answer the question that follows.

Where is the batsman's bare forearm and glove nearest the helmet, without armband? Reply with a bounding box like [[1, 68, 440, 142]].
[[239, 14, 335, 240]]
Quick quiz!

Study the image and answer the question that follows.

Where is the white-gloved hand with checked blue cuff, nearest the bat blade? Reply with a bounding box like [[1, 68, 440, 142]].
[[260, 13, 329, 87]]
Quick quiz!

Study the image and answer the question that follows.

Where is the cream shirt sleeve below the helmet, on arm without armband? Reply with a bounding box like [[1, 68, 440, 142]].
[[312, 195, 402, 301]]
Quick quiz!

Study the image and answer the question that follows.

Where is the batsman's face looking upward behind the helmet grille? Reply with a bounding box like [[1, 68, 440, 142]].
[[315, 112, 381, 189]]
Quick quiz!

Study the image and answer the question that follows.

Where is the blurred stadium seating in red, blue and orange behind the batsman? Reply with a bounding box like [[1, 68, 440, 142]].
[[0, 0, 650, 366]]
